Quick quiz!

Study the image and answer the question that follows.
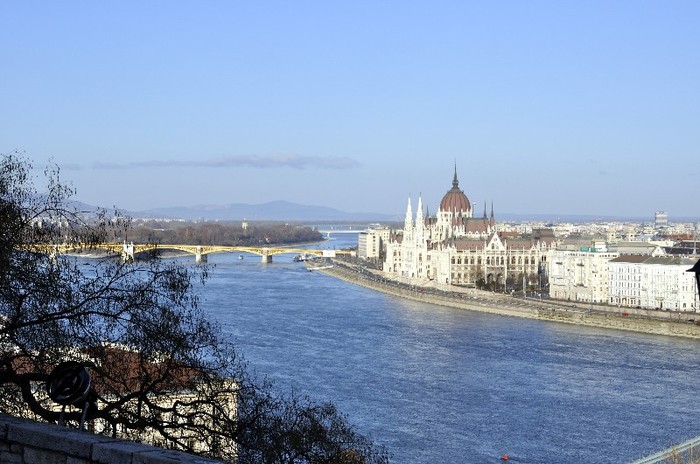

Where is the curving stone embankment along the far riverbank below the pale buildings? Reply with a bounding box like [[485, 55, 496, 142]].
[[308, 259, 700, 339]]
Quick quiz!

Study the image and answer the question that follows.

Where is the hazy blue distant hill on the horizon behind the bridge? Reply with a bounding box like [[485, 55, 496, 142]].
[[132, 200, 396, 222]]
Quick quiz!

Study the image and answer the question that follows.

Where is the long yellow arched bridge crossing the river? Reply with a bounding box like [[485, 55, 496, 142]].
[[51, 242, 354, 263]]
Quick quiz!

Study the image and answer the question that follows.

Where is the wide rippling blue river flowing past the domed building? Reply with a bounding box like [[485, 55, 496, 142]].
[[196, 235, 700, 464]]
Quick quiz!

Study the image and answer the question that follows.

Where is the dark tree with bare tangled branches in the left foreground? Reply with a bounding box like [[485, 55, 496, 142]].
[[0, 154, 388, 464]]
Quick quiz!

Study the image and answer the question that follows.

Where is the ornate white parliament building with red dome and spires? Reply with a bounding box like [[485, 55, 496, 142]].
[[370, 166, 555, 290]]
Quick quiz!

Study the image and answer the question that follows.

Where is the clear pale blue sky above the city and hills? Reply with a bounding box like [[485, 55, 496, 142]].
[[0, 0, 700, 220]]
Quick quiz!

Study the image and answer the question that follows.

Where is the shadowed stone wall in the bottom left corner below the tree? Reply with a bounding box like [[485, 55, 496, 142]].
[[0, 414, 217, 464]]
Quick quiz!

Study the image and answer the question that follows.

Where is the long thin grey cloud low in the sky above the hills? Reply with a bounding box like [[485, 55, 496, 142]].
[[91, 155, 360, 170]]
